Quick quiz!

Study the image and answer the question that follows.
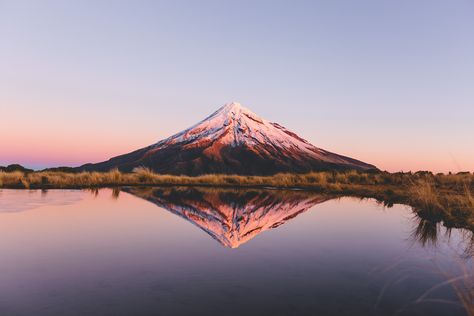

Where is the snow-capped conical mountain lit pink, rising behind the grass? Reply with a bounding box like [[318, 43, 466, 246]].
[[79, 103, 375, 175]]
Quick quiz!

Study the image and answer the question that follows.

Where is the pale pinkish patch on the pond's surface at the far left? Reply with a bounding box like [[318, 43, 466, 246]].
[[0, 189, 84, 212]]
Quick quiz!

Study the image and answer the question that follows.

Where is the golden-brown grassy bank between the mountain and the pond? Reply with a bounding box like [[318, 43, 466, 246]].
[[0, 168, 474, 229]]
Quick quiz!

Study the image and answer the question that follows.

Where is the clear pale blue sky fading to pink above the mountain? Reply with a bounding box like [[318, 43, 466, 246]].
[[0, 0, 474, 172]]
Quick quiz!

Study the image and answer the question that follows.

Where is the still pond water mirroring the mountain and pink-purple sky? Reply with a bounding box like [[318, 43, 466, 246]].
[[0, 188, 472, 316]]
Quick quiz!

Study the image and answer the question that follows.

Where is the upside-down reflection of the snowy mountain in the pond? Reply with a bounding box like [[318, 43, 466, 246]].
[[124, 188, 330, 248]]
